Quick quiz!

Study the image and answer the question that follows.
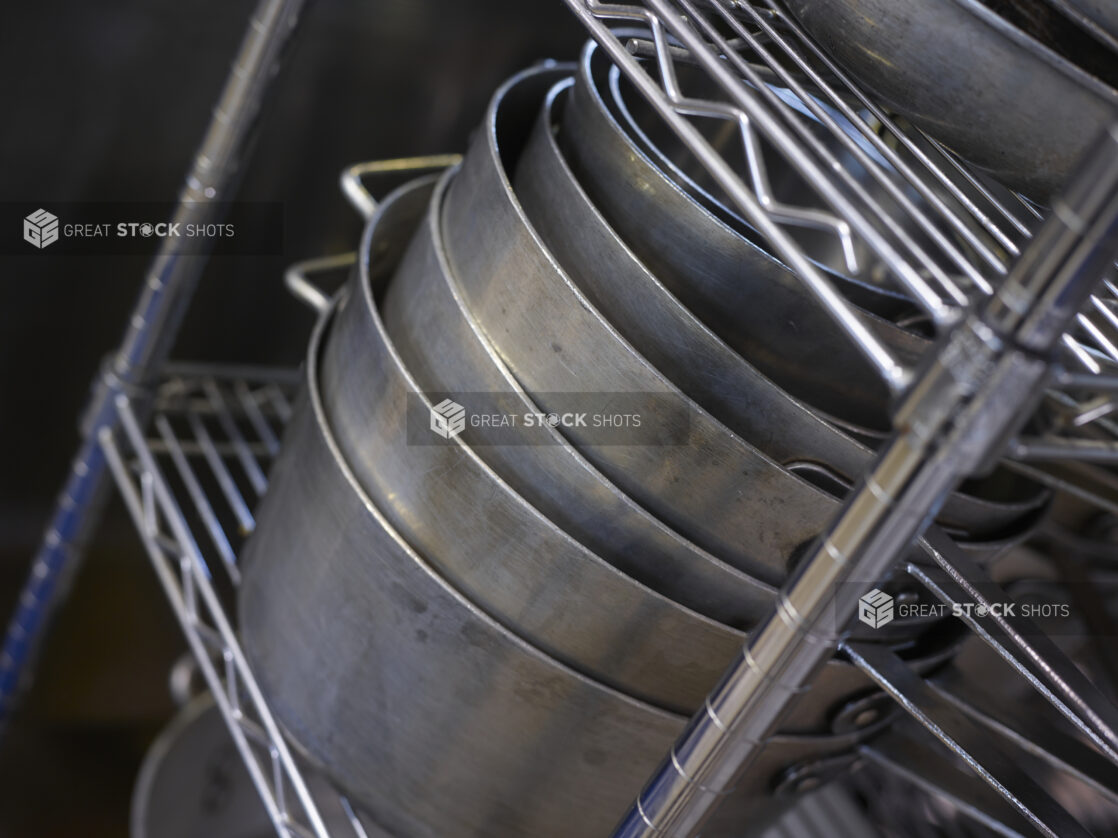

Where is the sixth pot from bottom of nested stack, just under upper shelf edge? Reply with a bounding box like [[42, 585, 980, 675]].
[[559, 42, 927, 431]]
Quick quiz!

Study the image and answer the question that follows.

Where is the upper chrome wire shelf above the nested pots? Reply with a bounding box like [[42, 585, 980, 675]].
[[566, 0, 1118, 453]]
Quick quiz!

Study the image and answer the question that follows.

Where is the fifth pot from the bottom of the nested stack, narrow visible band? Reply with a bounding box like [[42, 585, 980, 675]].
[[513, 80, 1045, 545]]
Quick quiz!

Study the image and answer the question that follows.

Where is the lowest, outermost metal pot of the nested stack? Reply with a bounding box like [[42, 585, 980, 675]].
[[239, 286, 858, 838]]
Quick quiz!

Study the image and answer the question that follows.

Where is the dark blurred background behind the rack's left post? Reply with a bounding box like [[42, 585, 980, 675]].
[[0, 0, 582, 838]]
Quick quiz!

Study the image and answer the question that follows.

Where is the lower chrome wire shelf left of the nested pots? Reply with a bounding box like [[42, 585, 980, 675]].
[[97, 365, 381, 838]]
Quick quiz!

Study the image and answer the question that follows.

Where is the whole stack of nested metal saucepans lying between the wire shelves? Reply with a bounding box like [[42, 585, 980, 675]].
[[239, 45, 1045, 838]]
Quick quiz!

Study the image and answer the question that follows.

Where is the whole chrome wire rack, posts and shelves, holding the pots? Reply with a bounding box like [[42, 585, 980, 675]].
[[0, 0, 1118, 838]]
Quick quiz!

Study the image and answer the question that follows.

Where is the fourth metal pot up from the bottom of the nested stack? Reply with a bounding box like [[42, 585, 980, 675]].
[[443, 60, 858, 583]]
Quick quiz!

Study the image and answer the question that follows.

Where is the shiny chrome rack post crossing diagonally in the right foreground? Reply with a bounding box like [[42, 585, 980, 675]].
[[615, 125, 1118, 838]]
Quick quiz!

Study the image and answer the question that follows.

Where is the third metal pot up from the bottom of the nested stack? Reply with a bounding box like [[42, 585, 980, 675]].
[[373, 160, 776, 629]]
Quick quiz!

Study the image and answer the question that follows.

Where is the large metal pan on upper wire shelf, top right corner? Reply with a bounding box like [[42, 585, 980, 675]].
[[788, 0, 1118, 202]]
